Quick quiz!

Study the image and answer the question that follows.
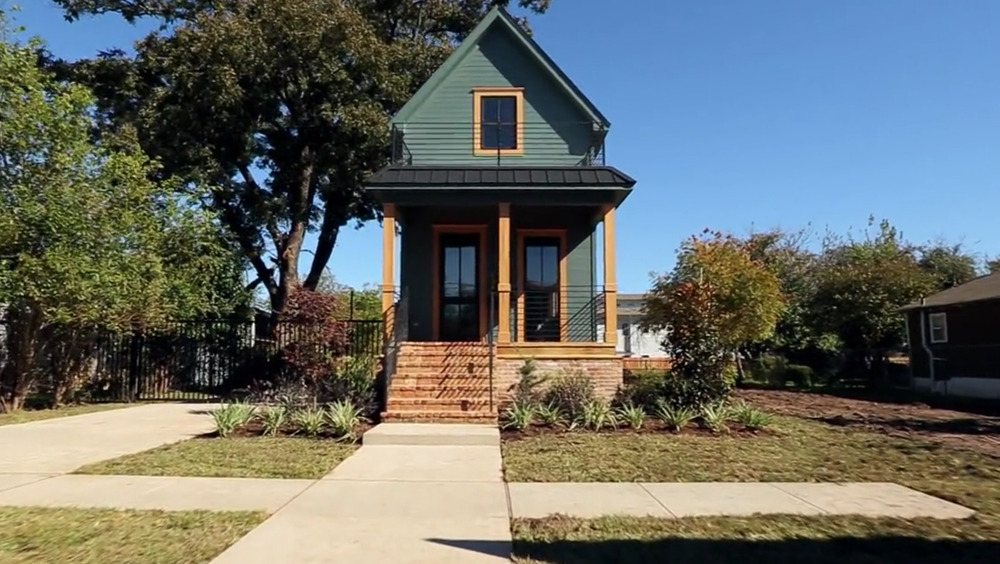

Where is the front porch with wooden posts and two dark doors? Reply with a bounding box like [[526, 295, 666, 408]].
[[382, 202, 617, 358]]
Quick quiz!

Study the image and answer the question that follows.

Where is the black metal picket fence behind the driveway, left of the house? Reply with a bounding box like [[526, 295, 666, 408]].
[[0, 319, 383, 402]]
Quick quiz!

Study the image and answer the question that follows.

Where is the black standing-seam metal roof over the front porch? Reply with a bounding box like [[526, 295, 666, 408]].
[[365, 166, 635, 188]]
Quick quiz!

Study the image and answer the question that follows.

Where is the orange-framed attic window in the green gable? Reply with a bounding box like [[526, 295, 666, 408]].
[[472, 88, 524, 156]]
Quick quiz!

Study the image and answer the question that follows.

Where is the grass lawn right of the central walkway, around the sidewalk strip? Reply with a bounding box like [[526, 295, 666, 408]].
[[503, 417, 1000, 564]]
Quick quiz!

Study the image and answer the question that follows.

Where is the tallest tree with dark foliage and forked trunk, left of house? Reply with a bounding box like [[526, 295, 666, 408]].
[[54, 0, 549, 312]]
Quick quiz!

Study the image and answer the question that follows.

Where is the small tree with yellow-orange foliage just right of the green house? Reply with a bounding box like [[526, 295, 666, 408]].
[[643, 232, 785, 390]]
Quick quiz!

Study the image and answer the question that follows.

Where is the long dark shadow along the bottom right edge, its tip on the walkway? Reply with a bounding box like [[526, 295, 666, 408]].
[[428, 537, 1000, 564]]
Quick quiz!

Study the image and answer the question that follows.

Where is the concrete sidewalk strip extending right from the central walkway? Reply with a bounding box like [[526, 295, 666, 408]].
[[508, 482, 975, 519]]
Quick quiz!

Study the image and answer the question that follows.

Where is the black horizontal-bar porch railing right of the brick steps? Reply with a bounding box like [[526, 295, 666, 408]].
[[498, 286, 605, 343]]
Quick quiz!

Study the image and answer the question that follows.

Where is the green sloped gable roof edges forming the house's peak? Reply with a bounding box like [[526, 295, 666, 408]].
[[393, 7, 611, 129]]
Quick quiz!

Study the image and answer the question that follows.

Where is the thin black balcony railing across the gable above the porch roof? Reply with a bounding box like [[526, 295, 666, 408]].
[[391, 121, 607, 166]]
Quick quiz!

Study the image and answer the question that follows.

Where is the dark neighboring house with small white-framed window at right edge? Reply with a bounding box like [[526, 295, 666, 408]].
[[903, 273, 1000, 399]]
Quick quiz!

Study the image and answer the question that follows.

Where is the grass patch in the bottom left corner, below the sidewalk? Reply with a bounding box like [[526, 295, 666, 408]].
[[0, 507, 267, 564]]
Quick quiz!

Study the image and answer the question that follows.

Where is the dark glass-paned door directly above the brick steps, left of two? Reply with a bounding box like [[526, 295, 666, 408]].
[[436, 233, 482, 341]]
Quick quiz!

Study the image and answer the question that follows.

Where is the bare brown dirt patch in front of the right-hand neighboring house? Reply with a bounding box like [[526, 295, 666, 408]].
[[736, 390, 1000, 457]]
